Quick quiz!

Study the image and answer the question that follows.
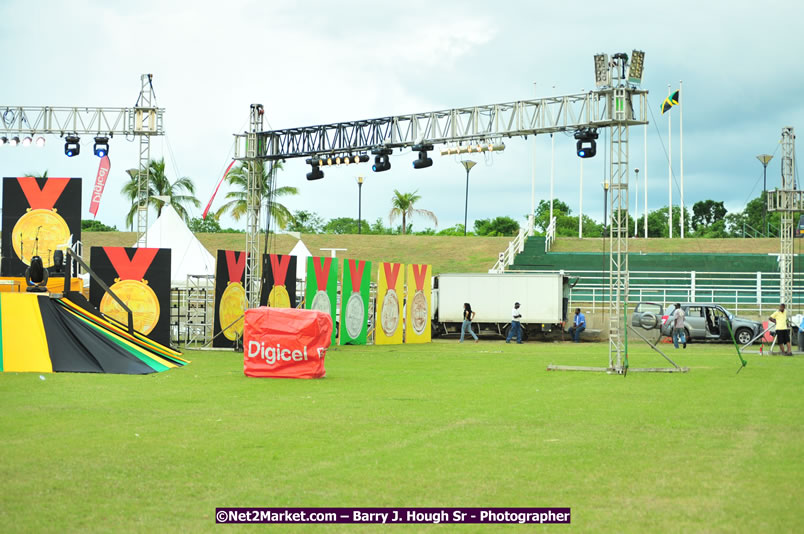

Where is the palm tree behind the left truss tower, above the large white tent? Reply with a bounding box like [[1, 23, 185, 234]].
[[120, 158, 201, 228]]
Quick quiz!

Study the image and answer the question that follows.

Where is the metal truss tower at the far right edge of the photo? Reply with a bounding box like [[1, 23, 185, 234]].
[[767, 126, 802, 314]]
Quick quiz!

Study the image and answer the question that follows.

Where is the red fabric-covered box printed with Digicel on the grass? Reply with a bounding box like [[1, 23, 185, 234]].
[[243, 307, 332, 378]]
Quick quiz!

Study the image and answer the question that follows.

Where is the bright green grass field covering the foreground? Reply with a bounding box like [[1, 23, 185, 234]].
[[0, 340, 804, 532]]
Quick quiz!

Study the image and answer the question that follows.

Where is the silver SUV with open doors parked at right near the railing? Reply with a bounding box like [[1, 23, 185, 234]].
[[631, 302, 762, 345]]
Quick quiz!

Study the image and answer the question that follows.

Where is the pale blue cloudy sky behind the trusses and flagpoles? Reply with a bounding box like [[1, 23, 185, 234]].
[[0, 0, 804, 236]]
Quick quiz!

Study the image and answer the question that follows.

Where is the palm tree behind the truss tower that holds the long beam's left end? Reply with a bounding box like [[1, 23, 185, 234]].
[[215, 161, 299, 229]]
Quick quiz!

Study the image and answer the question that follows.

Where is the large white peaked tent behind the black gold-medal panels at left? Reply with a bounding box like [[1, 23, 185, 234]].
[[133, 204, 215, 286]]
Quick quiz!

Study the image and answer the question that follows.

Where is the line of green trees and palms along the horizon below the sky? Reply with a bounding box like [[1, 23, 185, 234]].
[[80, 159, 780, 238]]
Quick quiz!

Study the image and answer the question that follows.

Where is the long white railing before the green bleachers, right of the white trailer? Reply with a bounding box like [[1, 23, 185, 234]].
[[520, 271, 804, 316]]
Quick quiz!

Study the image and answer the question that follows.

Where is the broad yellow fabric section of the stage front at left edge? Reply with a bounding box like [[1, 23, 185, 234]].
[[0, 293, 53, 373]]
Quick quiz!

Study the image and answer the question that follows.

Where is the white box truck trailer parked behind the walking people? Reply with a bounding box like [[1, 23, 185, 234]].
[[432, 273, 569, 339]]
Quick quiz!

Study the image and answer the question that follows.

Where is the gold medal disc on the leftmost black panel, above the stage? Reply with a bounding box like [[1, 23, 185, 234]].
[[11, 209, 70, 267]]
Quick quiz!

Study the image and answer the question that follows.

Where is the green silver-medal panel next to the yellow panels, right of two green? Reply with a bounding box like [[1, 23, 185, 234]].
[[340, 260, 371, 345]]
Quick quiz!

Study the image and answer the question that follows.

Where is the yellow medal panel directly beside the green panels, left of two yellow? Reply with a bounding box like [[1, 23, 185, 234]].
[[374, 263, 405, 345]]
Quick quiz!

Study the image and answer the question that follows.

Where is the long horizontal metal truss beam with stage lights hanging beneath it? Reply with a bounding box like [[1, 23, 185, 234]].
[[235, 88, 647, 160]]
